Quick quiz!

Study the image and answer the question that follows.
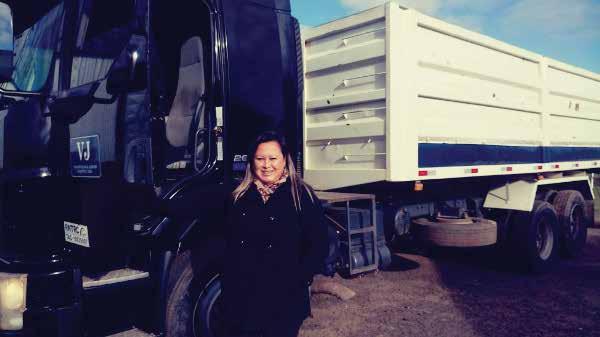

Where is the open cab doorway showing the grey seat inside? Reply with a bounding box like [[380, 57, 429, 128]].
[[152, 1, 214, 175]]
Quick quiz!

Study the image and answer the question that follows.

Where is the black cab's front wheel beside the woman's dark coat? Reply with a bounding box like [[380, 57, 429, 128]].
[[165, 251, 226, 337]]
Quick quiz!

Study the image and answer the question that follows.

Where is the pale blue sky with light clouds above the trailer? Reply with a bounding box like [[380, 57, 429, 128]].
[[291, 0, 600, 74]]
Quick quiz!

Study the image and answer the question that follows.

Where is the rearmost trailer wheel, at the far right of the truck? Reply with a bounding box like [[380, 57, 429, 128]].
[[553, 190, 587, 257]]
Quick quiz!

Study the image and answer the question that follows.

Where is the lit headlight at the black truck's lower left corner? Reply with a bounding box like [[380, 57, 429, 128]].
[[0, 273, 27, 330]]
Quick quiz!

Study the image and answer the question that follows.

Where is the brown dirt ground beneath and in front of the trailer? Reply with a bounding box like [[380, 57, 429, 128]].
[[300, 228, 600, 337]]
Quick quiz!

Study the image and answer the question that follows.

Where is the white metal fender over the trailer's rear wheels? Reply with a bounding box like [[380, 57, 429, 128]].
[[483, 175, 594, 212]]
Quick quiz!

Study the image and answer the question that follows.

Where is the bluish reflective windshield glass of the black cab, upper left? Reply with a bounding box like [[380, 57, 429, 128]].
[[3, 3, 64, 91]]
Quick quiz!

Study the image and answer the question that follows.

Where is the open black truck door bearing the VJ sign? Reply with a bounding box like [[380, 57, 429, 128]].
[[62, 0, 152, 272]]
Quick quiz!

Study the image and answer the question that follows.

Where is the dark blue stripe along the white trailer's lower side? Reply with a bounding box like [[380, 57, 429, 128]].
[[419, 143, 600, 168]]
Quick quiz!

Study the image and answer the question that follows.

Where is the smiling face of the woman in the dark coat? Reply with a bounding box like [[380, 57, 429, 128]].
[[254, 140, 285, 185]]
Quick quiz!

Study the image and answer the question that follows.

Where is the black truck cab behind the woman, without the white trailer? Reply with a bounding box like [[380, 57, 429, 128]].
[[0, 0, 310, 337]]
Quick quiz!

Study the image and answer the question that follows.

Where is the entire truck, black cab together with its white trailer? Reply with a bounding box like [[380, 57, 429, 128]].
[[0, 0, 600, 337]]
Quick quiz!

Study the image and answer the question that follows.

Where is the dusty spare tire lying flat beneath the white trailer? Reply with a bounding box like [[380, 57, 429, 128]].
[[413, 218, 498, 247]]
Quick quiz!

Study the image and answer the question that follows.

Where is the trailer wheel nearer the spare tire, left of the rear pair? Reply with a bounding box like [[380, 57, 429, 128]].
[[510, 200, 559, 273]]
